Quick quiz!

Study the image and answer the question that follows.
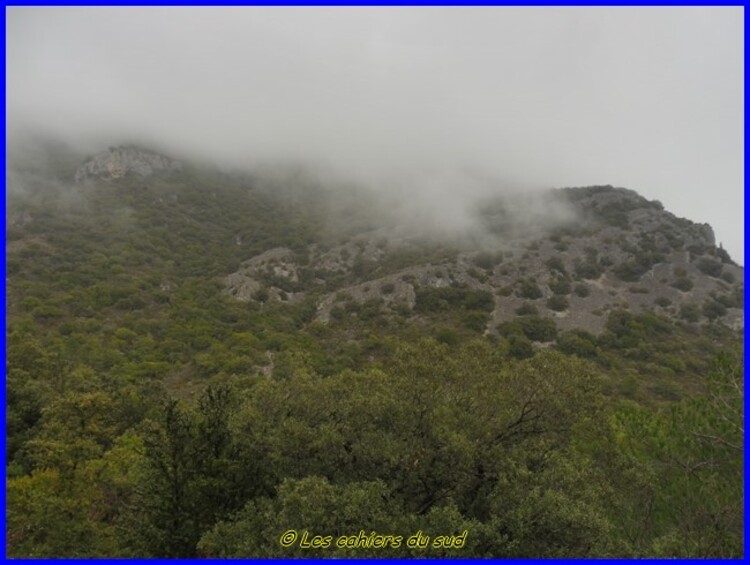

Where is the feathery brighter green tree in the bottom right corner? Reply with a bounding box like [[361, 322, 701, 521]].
[[614, 348, 744, 557]]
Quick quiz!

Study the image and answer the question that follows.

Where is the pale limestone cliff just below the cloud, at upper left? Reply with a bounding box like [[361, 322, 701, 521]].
[[75, 146, 182, 183]]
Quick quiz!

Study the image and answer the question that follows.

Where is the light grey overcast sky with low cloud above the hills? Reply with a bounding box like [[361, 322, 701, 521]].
[[6, 7, 744, 263]]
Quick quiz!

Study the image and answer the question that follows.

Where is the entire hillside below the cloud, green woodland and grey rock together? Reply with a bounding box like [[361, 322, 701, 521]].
[[6, 145, 744, 557]]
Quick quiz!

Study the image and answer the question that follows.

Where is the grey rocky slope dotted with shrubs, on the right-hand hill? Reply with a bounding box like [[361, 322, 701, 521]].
[[225, 187, 744, 333]]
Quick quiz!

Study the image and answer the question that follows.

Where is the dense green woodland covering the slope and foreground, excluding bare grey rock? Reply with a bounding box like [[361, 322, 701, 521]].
[[6, 152, 744, 557]]
